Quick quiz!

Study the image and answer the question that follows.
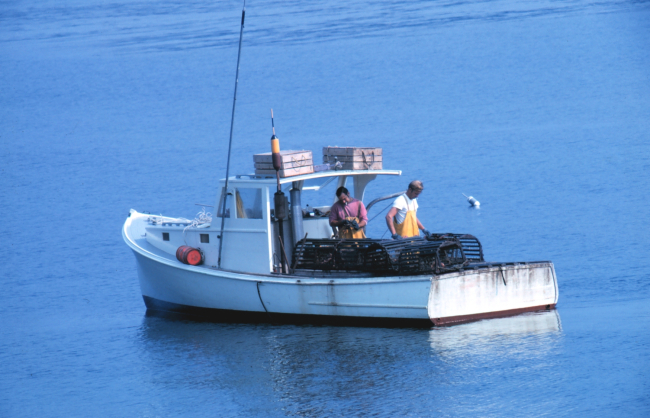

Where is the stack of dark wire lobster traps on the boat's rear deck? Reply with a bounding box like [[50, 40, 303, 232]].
[[293, 234, 485, 275]]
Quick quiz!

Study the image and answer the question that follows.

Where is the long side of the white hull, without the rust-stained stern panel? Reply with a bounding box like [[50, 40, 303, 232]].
[[135, 251, 431, 325]]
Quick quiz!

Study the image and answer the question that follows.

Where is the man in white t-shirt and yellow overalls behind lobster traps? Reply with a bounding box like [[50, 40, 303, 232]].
[[386, 180, 429, 239]]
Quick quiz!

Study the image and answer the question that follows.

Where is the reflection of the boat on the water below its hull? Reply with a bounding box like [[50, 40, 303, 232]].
[[136, 310, 562, 416]]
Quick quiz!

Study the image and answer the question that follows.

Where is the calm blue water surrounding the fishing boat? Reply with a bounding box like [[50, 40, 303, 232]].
[[0, 0, 650, 417]]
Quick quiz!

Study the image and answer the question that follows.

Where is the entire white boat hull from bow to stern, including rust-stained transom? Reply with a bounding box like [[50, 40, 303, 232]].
[[123, 211, 557, 326]]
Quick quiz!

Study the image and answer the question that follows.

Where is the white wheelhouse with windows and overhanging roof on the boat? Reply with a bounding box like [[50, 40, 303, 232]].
[[147, 170, 401, 274]]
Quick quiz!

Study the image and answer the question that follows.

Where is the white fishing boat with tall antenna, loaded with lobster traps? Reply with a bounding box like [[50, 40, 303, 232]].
[[122, 4, 558, 327]]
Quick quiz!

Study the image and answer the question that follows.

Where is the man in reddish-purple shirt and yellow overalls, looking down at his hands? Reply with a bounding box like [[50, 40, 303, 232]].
[[330, 187, 368, 239]]
